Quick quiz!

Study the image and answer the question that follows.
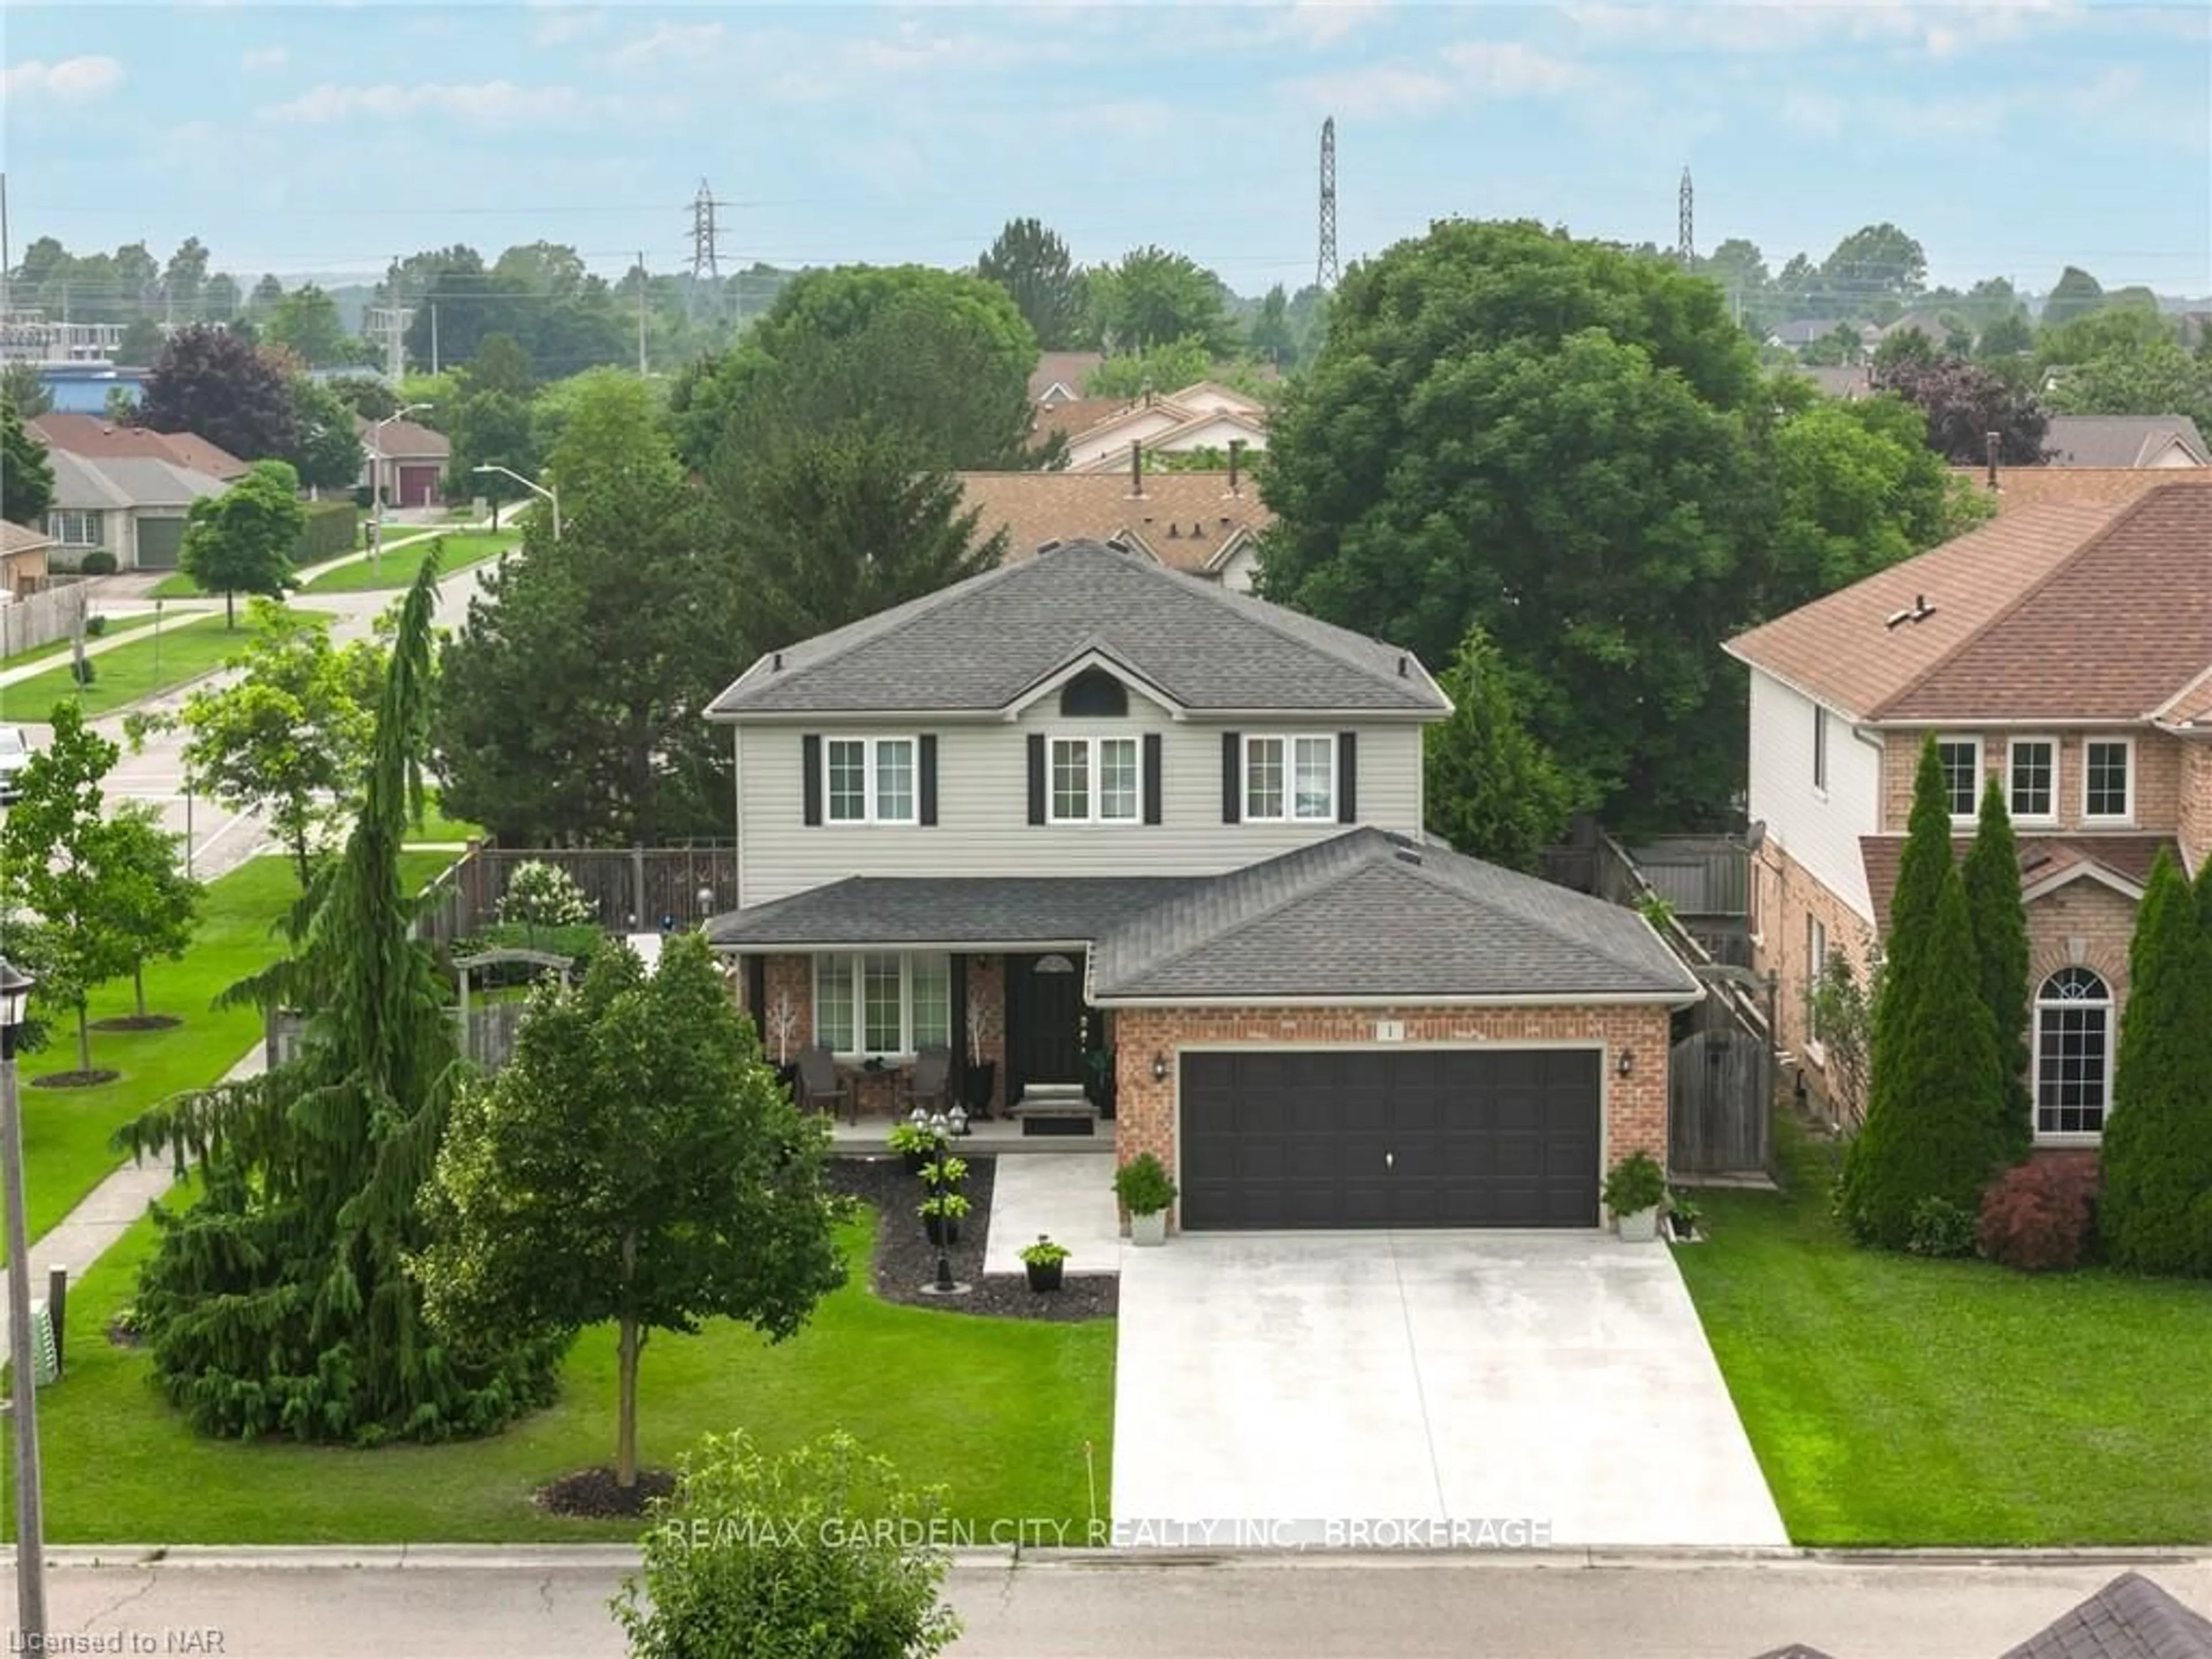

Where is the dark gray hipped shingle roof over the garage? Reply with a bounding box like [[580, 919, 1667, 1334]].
[[1090, 830, 1696, 1002]]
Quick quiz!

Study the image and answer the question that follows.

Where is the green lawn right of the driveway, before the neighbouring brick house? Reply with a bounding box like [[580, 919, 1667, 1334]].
[[1675, 1124, 2212, 1546]]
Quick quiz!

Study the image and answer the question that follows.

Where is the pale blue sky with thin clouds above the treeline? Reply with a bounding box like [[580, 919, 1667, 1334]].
[[0, 0, 2212, 294]]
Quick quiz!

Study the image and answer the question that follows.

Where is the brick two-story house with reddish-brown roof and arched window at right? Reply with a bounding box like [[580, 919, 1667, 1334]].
[[1728, 484, 2212, 1146]]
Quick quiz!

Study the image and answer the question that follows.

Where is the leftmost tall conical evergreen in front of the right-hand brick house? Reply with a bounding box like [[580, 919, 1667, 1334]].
[[1843, 739, 2006, 1250]]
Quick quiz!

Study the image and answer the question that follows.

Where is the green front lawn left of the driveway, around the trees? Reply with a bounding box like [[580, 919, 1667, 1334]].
[[37, 1217, 1115, 1544]]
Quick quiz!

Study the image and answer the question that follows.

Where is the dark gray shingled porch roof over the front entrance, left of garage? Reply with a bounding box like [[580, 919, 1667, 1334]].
[[706, 876, 1206, 949]]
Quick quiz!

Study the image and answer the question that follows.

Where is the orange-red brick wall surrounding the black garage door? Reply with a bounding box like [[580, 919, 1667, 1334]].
[[1113, 1006, 1668, 1238]]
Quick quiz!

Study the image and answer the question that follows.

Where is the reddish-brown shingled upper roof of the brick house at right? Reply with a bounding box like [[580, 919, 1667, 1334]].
[[1725, 484, 2212, 721]]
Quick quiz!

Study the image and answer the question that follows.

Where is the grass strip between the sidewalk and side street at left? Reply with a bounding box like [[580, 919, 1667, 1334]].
[[22, 851, 467, 1238]]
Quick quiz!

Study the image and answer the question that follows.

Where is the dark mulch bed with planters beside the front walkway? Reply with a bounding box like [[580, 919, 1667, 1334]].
[[830, 1153, 1122, 1319]]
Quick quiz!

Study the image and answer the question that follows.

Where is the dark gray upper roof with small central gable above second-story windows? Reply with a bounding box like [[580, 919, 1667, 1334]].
[[708, 542, 1445, 717]]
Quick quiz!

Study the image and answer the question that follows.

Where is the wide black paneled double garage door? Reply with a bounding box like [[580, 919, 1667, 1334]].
[[1181, 1048, 1601, 1232]]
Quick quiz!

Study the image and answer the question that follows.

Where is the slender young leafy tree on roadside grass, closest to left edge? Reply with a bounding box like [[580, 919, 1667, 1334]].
[[0, 701, 135, 1084]]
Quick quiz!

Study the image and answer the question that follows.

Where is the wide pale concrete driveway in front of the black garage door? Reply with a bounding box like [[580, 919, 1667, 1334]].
[[1113, 1232, 1787, 1548]]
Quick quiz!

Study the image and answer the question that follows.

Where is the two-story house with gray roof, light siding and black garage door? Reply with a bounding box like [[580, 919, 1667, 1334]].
[[708, 542, 1696, 1228]]
